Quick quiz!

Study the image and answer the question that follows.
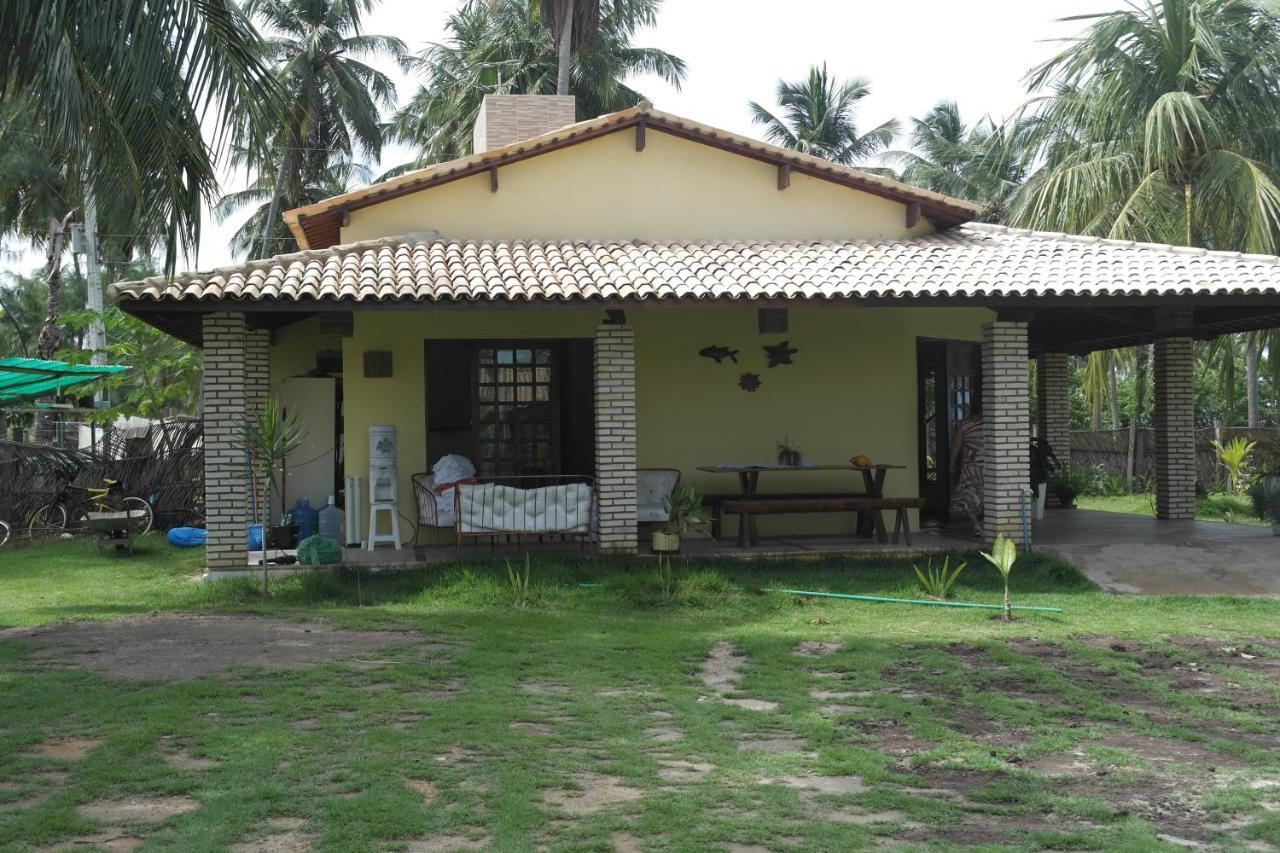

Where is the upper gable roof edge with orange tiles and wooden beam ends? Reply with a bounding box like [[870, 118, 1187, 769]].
[[284, 101, 982, 248]]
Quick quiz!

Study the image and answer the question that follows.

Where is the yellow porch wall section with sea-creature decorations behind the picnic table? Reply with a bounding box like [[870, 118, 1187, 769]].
[[627, 307, 992, 534]]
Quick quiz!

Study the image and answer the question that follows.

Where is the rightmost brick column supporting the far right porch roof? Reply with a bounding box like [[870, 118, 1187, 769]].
[[1152, 338, 1196, 519]]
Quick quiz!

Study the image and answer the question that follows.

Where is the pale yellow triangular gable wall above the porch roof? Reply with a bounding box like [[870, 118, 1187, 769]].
[[342, 129, 933, 243]]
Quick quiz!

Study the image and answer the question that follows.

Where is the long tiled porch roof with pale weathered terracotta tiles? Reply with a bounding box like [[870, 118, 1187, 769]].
[[111, 224, 1280, 302]]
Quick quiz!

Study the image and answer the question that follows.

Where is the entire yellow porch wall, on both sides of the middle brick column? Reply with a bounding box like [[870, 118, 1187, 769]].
[[271, 307, 992, 539]]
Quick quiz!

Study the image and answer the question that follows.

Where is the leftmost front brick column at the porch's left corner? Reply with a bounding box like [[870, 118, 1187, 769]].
[[201, 314, 248, 573]]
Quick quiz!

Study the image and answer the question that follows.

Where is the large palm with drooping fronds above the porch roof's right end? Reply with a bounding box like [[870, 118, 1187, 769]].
[[1012, 0, 1280, 254]]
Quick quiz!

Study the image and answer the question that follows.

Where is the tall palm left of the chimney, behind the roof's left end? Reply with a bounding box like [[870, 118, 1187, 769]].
[[234, 0, 406, 257]]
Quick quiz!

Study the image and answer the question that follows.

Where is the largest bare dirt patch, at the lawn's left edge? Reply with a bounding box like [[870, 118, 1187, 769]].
[[0, 615, 428, 681]]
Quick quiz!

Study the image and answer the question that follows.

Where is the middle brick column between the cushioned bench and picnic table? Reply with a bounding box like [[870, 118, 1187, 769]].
[[595, 324, 636, 553]]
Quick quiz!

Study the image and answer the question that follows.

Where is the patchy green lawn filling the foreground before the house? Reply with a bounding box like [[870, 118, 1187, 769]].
[[0, 539, 1280, 850]]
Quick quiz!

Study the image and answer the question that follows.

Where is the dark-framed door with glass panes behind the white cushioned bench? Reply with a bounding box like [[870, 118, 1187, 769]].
[[472, 342, 559, 476]]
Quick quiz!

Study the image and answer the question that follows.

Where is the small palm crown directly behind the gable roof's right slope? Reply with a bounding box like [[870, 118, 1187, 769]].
[[749, 64, 899, 165]]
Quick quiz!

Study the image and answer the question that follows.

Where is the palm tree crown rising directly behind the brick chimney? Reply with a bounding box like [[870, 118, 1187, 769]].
[[388, 0, 685, 167]]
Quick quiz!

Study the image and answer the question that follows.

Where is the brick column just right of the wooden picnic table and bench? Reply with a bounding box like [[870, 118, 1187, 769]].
[[982, 320, 1030, 542]]
